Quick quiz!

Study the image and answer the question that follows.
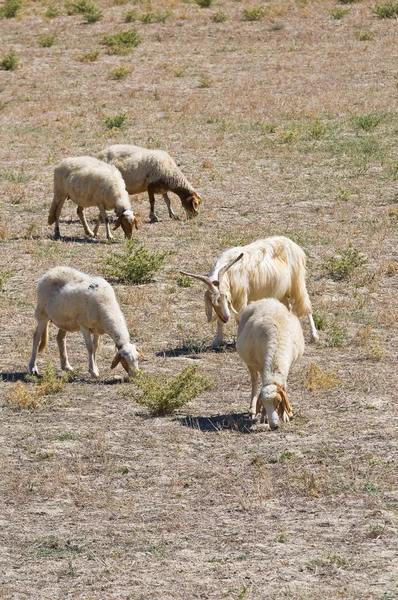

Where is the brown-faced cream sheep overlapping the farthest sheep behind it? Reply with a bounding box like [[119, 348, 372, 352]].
[[48, 156, 138, 240]]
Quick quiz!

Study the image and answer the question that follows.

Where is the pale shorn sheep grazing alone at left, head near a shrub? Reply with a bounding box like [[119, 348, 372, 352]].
[[29, 267, 142, 377]]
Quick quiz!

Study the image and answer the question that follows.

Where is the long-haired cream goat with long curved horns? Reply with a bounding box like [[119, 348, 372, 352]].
[[181, 236, 319, 348]]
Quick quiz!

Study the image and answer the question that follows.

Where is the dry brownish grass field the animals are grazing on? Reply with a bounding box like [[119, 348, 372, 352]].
[[0, 0, 398, 600]]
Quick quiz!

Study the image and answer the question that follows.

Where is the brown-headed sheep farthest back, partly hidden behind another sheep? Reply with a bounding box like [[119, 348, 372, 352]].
[[97, 144, 201, 223]]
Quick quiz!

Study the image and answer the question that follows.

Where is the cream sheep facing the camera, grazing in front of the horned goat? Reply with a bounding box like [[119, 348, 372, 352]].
[[236, 298, 304, 429]]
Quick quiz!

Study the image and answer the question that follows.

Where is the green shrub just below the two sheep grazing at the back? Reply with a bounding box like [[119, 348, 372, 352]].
[[103, 239, 168, 283]]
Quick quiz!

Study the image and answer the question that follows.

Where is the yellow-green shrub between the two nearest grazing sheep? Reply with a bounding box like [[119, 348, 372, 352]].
[[128, 365, 211, 417]]
